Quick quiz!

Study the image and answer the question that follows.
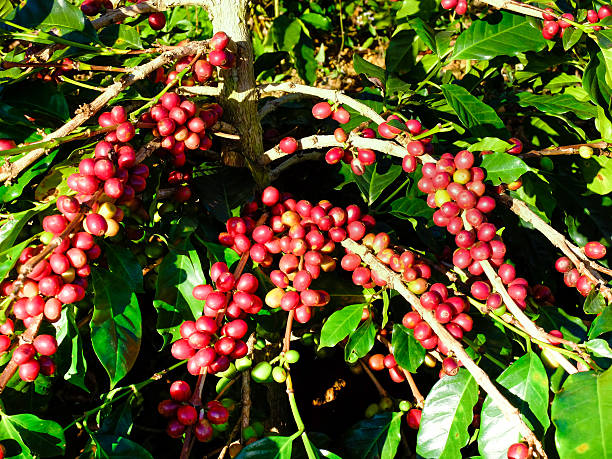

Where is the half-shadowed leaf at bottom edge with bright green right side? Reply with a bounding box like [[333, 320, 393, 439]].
[[344, 412, 403, 459]]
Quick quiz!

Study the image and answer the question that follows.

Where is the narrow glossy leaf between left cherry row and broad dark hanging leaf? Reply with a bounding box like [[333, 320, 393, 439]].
[[55, 305, 89, 392]]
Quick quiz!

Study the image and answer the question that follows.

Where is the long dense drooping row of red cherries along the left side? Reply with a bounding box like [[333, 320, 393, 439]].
[[0, 106, 149, 381]]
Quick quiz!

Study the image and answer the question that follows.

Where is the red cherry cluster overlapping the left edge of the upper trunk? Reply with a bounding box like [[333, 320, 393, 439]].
[[163, 31, 236, 86]]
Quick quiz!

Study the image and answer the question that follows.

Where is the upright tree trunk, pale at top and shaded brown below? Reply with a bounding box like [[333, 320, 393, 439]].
[[208, 0, 269, 188]]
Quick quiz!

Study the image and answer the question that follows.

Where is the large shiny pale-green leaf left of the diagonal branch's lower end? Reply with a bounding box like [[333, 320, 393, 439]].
[[417, 368, 478, 459]]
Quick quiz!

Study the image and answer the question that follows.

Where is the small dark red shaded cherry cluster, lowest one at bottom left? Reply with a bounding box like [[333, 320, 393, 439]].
[[157, 380, 229, 442]]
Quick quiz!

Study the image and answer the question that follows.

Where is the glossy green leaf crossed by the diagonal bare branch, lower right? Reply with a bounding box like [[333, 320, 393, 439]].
[[478, 352, 550, 459]]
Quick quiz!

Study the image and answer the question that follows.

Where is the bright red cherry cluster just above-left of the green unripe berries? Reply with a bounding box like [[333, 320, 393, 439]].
[[171, 262, 256, 375]]
